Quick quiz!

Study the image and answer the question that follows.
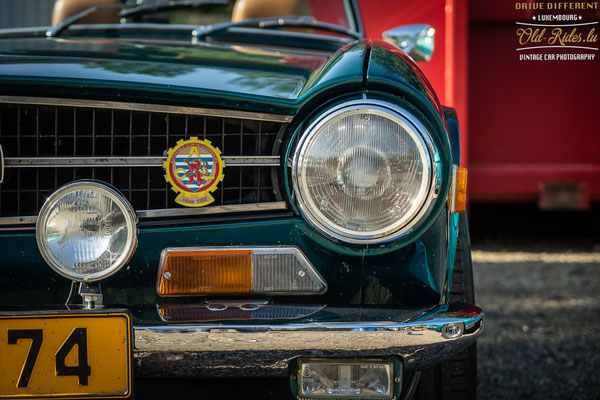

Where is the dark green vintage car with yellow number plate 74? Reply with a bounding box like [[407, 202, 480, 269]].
[[0, 0, 483, 399]]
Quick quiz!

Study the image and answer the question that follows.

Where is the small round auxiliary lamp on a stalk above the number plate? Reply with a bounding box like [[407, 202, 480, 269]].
[[36, 182, 137, 282]]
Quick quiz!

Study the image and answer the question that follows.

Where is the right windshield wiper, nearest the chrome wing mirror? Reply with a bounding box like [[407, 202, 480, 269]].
[[192, 15, 360, 40]]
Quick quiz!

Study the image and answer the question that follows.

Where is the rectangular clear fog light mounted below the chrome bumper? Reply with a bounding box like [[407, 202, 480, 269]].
[[297, 358, 394, 399]]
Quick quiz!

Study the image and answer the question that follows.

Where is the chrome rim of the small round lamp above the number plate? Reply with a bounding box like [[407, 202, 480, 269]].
[[35, 180, 138, 282]]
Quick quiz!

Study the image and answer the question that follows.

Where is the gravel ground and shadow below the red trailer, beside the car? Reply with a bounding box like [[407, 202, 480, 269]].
[[471, 208, 600, 400]]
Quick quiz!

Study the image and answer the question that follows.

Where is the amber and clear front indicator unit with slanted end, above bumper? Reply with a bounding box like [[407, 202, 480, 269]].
[[156, 247, 327, 296]]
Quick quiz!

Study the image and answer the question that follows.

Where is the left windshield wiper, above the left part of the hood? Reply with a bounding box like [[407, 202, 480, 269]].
[[46, 0, 228, 37]]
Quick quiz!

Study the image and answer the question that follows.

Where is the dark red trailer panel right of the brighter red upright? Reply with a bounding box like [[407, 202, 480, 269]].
[[469, 0, 600, 207]]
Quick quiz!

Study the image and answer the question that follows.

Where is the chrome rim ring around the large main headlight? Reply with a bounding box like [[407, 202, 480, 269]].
[[291, 99, 442, 245]]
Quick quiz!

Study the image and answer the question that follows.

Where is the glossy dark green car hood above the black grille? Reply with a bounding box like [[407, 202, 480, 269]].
[[0, 37, 366, 114]]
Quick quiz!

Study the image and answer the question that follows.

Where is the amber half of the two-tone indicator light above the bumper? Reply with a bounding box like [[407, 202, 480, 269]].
[[157, 250, 252, 296]]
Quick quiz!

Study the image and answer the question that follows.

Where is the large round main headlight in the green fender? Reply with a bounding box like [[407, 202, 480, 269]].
[[293, 103, 436, 243]]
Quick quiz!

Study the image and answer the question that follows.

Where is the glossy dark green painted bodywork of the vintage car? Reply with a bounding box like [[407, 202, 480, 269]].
[[0, 32, 455, 308]]
